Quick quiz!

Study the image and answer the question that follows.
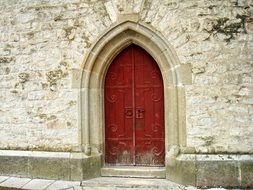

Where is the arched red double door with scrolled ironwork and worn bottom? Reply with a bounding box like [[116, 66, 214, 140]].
[[104, 45, 165, 166]]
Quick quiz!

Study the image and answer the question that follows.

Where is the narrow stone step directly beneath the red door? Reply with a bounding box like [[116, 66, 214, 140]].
[[101, 166, 166, 179]]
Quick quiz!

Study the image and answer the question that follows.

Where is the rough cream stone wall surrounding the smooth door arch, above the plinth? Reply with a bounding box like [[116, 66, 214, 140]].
[[0, 0, 253, 152]]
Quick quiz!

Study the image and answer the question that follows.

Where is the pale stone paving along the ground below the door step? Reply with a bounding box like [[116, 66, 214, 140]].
[[0, 176, 237, 190]]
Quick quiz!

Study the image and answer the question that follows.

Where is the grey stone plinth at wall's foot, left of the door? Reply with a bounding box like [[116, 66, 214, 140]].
[[0, 150, 101, 180]]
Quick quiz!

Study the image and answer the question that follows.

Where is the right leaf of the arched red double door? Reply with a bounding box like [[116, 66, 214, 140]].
[[134, 46, 165, 166]]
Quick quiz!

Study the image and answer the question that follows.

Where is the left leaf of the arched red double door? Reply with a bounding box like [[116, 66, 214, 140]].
[[105, 45, 133, 165]]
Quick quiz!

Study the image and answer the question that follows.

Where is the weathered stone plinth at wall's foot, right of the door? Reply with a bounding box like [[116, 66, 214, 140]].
[[166, 154, 253, 188]]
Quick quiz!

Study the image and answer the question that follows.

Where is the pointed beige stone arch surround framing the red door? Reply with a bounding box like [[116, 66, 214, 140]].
[[78, 21, 191, 177]]
